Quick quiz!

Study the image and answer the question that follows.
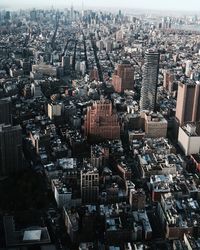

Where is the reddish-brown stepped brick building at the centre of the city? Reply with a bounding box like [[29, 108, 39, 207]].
[[84, 100, 120, 140]]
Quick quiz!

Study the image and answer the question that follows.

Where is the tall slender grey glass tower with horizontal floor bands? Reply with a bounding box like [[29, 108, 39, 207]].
[[140, 50, 160, 111]]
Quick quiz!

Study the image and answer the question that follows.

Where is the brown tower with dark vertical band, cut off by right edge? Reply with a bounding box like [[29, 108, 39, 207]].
[[176, 82, 200, 125]]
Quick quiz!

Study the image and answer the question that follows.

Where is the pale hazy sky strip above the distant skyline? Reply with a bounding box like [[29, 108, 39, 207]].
[[0, 0, 200, 11]]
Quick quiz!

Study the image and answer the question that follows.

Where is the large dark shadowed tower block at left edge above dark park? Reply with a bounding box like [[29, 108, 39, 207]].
[[0, 124, 23, 176]]
